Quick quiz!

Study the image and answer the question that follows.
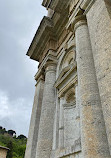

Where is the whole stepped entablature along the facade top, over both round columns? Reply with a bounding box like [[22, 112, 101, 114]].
[[27, 0, 94, 63]]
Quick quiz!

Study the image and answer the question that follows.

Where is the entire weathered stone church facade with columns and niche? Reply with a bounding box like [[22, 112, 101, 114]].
[[25, 0, 111, 158]]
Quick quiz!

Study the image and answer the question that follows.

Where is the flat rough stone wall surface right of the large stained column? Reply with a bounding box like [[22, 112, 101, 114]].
[[87, 0, 111, 152]]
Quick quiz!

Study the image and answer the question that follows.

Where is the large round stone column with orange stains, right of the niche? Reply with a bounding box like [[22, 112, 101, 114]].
[[75, 17, 110, 158]]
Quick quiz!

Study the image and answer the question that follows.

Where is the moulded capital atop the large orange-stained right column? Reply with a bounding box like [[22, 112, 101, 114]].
[[72, 15, 87, 31]]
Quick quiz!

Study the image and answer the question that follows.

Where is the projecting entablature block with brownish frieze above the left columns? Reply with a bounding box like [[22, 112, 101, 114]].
[[27, 9, 68, 63]]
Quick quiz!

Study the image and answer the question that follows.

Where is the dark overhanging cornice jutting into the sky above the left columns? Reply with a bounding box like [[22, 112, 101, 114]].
[[27, 16, 55, 61]]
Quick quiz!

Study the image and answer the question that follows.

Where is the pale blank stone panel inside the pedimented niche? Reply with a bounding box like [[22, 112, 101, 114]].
[[63, 103, 80, 147]]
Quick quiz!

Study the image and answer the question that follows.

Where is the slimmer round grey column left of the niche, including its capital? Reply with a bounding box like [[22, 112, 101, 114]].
[[36, 62, 56, 158]]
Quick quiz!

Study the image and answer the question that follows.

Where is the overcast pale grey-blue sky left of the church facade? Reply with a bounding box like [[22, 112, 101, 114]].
[[0, 0, 46, 136]]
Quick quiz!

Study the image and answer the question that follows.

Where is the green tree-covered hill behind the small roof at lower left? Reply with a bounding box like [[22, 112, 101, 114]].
[[0, 126, 27, 158]]
